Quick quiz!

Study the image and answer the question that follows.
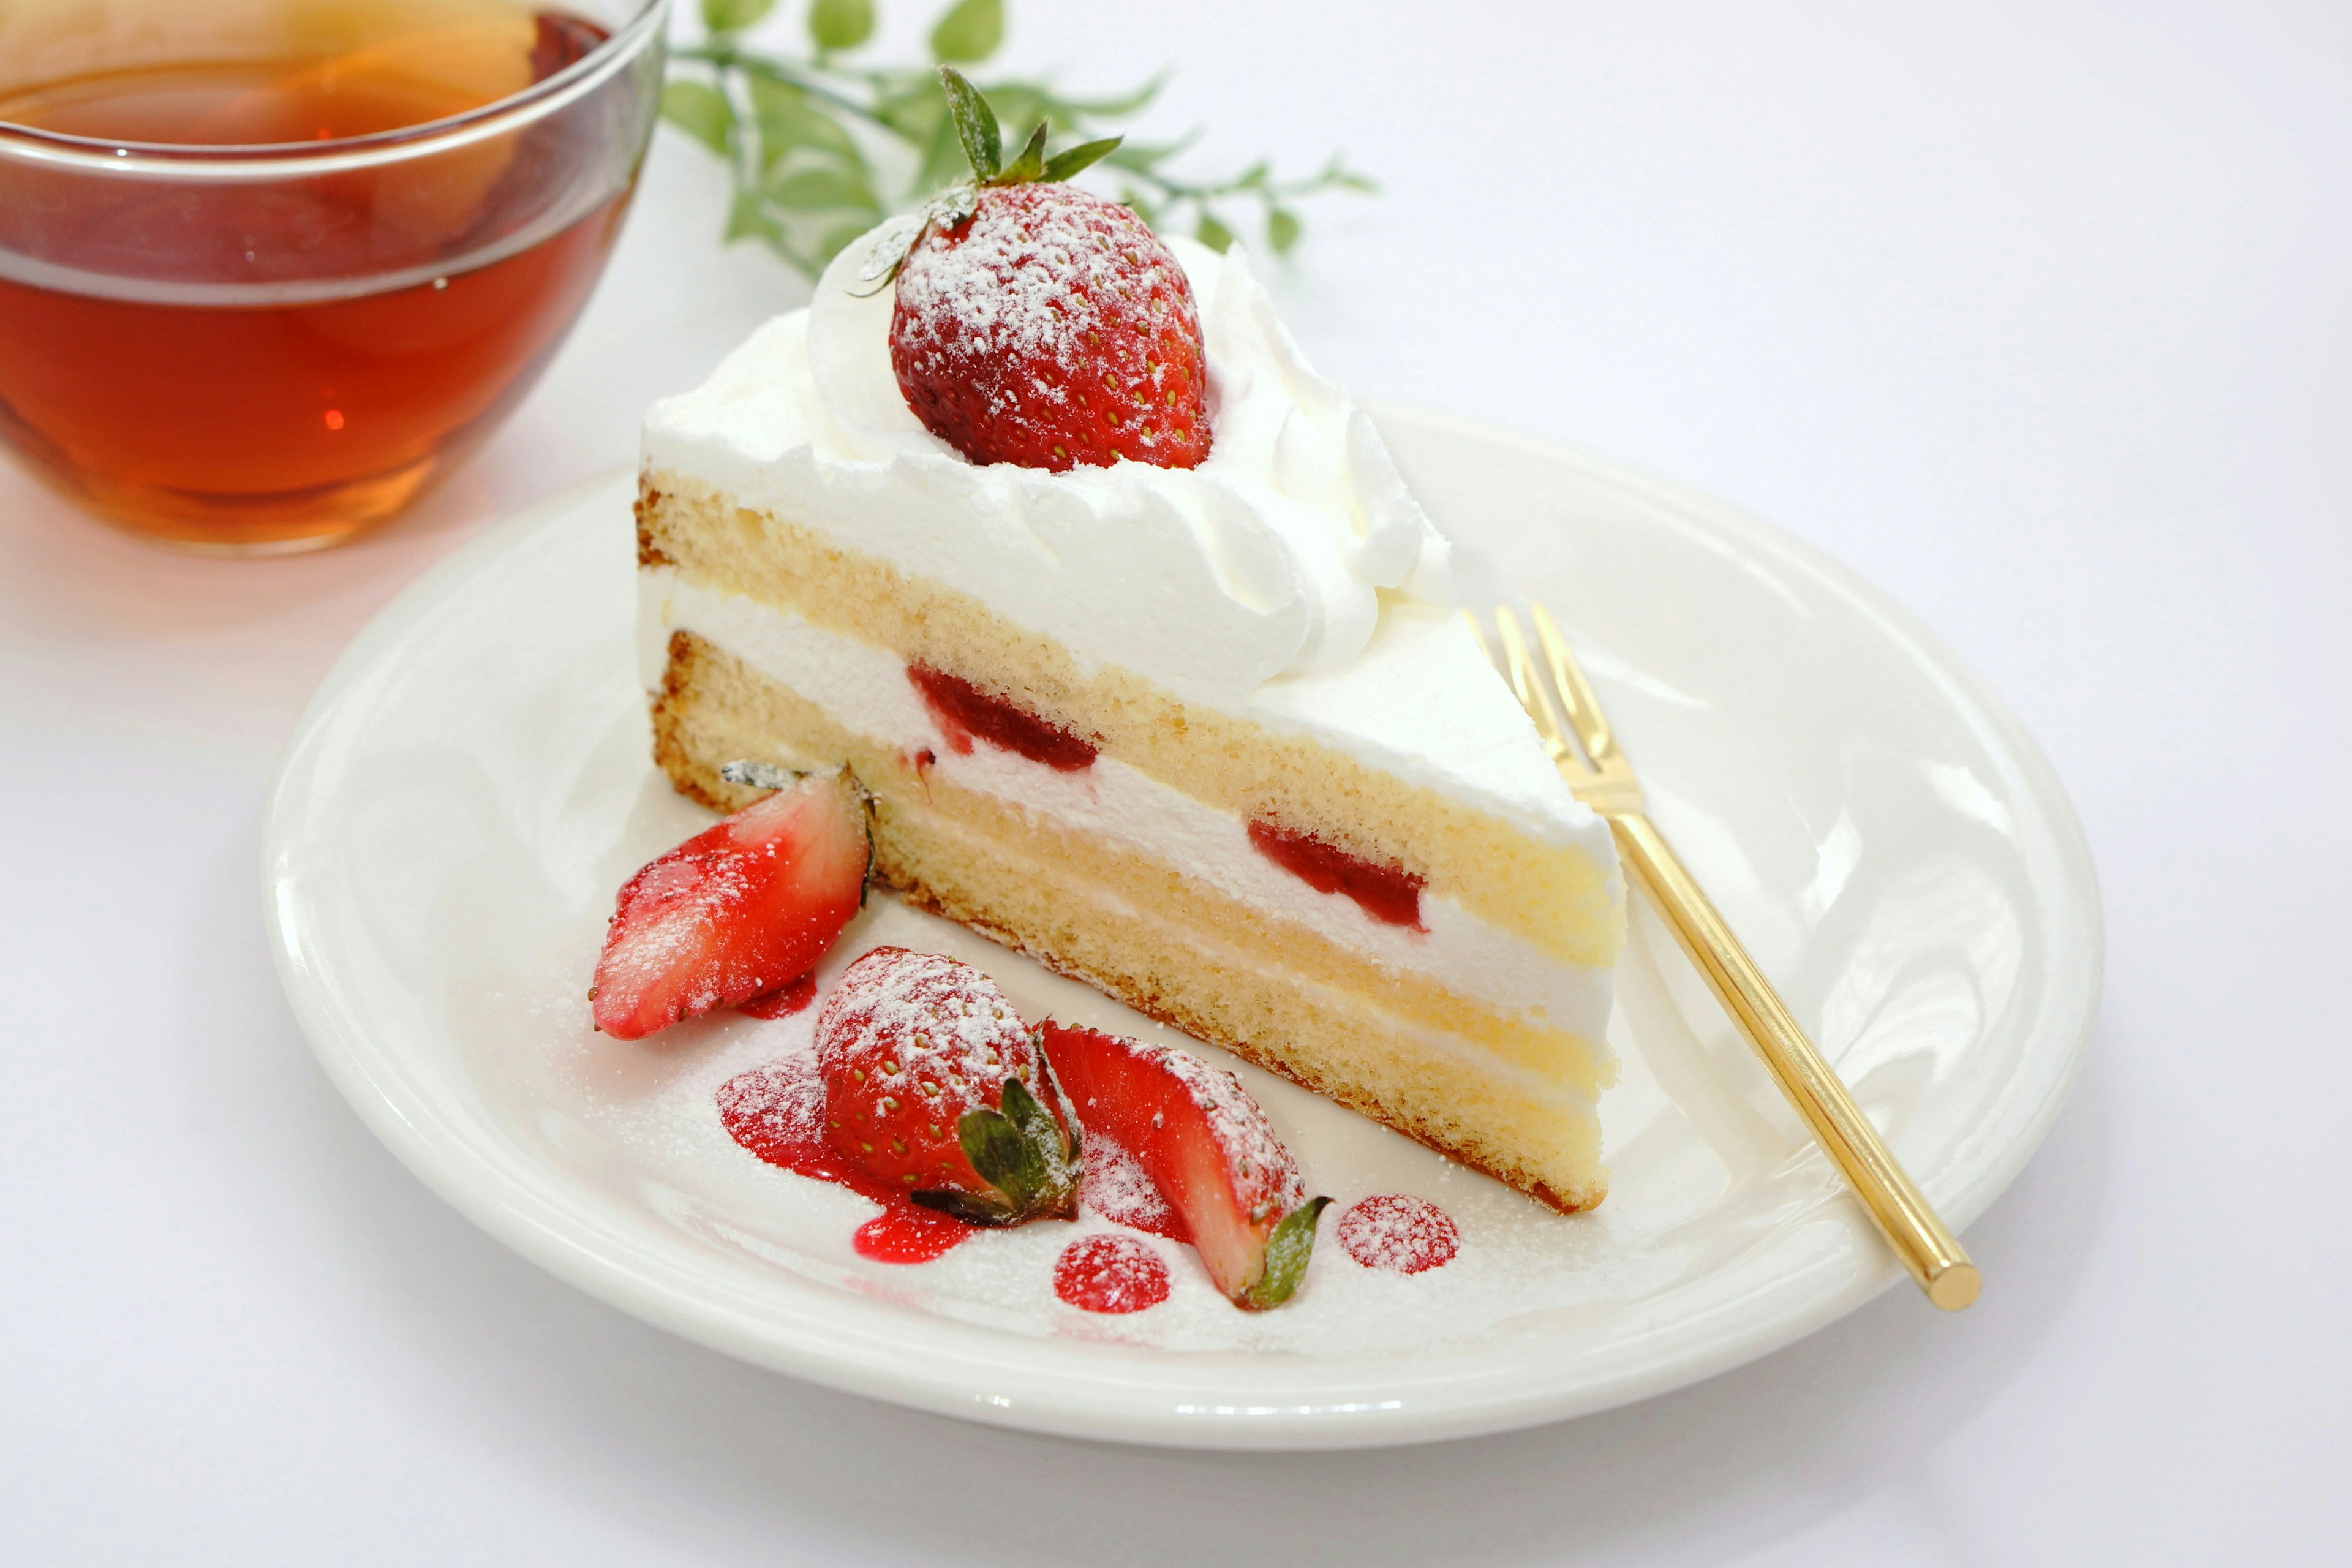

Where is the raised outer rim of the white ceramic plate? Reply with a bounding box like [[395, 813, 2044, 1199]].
[[261, 402, 2105, 1450]]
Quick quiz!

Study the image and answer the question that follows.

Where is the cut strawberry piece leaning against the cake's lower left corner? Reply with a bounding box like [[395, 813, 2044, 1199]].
[[588, 769, 873, 1039]]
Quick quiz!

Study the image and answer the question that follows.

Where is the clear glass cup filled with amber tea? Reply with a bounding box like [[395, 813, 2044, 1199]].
[[0, 0, 658, 550]]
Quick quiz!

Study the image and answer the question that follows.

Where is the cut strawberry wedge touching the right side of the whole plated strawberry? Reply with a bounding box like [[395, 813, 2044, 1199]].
[[1039, 1023, 1331, 1312]]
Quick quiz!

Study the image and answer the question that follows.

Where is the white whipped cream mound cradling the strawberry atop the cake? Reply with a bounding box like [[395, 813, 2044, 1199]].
[[644, 225, 1453, 707]]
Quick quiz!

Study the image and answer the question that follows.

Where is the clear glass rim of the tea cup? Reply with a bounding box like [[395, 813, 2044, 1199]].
[[0, 0, 670, 181]]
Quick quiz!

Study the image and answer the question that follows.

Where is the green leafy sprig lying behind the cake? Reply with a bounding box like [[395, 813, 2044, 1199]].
[[661, 0, 1378, 277]]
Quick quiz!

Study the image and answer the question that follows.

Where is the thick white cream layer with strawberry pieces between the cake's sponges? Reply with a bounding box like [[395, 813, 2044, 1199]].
[[638, 567, 1609, 1049]]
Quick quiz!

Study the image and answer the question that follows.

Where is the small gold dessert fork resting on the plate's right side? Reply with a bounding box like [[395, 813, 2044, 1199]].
[[1463, 604, 1983, 1312]]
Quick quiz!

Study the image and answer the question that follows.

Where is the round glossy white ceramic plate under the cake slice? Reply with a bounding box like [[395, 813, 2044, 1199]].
[[266, 409, 2100, 1448]]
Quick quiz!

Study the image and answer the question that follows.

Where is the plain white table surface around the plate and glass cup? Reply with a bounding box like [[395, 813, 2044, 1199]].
[[0, 0, 2352, 1568]]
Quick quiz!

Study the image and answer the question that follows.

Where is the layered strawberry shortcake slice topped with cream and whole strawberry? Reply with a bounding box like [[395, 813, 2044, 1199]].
[[638, 70, 1625, 1211]]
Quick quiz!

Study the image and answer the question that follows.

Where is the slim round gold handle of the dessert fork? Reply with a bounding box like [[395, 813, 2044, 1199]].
[[1609, 811, 1980, 1312]]
